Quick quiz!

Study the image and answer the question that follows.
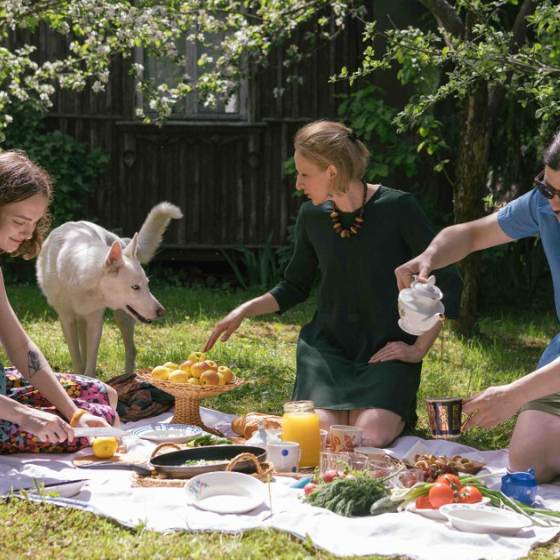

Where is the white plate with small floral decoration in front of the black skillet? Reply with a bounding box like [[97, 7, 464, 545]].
[[185, 471, 266, 513]]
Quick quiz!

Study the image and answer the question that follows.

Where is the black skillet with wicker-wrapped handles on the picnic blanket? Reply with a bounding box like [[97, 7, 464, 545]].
[[150, 445, 266, 478]]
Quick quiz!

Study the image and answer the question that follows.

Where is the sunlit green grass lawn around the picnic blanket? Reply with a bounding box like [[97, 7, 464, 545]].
[[0, 285, 560, 560]]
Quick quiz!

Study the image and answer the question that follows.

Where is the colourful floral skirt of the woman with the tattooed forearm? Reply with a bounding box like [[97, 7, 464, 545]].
[[0, 368, 116, 454]]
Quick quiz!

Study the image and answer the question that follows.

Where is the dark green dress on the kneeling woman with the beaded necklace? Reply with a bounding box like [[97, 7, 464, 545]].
[[270, 186, 462, 426]]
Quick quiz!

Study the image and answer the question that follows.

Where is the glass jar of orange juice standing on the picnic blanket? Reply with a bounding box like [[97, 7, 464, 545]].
[[282, 401, 321, 467]]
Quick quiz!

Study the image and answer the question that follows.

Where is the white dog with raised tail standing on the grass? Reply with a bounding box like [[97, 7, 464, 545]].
[[37, 202, 183, 376]]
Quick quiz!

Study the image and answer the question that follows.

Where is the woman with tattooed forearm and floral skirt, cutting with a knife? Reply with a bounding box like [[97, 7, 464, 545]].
[[0, 150, 118, 453]]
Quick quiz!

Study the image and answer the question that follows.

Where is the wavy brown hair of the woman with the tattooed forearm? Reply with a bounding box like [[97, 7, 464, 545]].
[[0, 150, 53, 259]]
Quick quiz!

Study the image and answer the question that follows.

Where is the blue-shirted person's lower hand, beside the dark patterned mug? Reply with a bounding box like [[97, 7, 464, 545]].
[[463, 385, 522, 430]]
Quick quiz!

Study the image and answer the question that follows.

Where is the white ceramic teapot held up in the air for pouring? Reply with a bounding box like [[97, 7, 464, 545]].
[[399, 276, 445, 336]]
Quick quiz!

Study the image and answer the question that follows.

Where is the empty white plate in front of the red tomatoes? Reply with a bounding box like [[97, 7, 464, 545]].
[[440, 504, 533, 535]]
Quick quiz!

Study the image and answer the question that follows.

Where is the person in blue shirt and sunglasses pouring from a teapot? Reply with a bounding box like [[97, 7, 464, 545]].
[[395, 133, 560, 482]]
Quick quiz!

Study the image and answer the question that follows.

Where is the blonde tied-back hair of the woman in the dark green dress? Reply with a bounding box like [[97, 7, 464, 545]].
[[294, 121, 369, 193]]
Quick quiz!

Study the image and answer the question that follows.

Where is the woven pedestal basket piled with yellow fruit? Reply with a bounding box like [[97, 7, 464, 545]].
[[138, 352, 243, 435]]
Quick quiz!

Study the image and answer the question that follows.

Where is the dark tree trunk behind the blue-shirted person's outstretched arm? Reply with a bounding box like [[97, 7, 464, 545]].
[[454, 82, 491, 333]]
